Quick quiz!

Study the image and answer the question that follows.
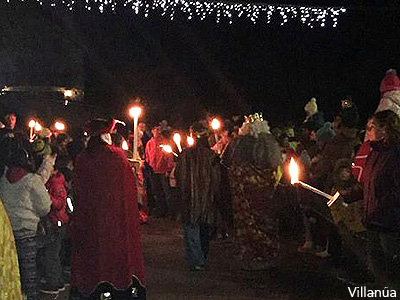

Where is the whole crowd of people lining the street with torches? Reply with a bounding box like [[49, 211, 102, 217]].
[[0, 70, 400, 300]]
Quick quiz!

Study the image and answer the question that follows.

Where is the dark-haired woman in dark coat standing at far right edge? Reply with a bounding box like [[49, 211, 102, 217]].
[[351, 110, 400, 285]]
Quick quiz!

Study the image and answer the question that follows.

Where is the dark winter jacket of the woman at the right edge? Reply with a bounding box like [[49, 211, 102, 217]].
[[363, 141, 400, 231]]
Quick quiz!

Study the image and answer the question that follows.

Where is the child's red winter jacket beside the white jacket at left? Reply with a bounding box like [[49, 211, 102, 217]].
[[46, 172, 68, 225]]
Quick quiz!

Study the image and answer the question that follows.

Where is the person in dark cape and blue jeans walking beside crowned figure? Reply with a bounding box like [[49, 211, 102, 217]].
[[175, 123, 220, 271]]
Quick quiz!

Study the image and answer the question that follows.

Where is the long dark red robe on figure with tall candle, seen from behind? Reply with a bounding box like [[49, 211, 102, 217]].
[[71, 145, 144, 295]]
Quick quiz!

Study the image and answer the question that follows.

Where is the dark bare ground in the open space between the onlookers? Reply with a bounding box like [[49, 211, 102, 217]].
[[38, 219, 360, 300]]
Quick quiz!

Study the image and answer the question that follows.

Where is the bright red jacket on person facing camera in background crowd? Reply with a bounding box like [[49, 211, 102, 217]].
[[146, 137, 174, 174]]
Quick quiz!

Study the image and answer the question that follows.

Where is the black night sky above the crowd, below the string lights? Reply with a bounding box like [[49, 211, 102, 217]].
[[0, 1, 400, 126]]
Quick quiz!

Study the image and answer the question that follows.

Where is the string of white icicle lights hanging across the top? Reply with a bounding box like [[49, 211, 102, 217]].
[[6, 0, 346, 28]]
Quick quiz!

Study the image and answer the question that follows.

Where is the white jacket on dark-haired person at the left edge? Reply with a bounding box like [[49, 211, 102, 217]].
[[0, 173, 51, 238]]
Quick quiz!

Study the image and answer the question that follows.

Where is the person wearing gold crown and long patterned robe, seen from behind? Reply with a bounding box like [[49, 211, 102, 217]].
[[226, 114, 281, 269]]
